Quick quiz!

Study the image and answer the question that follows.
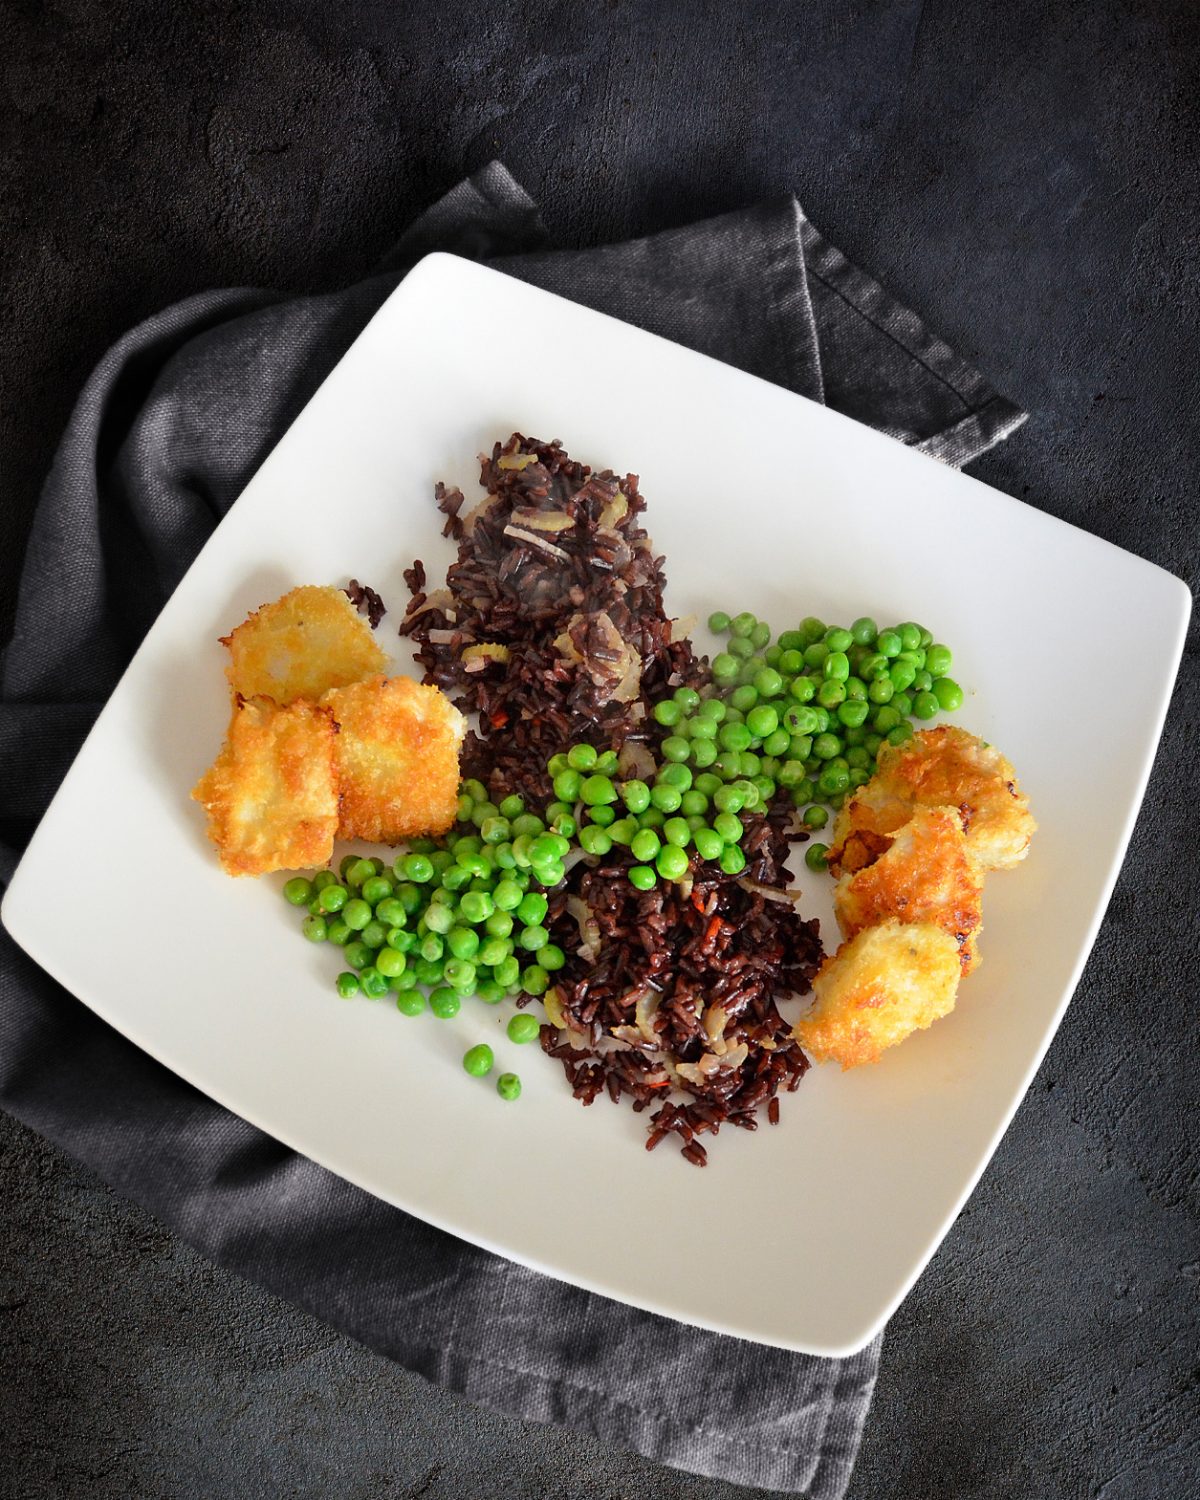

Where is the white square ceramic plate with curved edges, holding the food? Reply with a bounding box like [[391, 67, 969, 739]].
[[3, 255, 1191, 1355]]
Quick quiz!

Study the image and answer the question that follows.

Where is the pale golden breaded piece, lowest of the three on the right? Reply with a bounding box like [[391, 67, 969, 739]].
[[792, 921, 959, 1068]]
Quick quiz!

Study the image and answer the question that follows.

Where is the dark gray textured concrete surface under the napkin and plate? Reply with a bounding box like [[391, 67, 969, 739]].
[[0, 0, 1200, 1500]]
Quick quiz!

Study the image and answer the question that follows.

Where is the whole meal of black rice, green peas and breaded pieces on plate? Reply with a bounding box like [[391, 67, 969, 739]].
[[194, 434, 1035, 1166]]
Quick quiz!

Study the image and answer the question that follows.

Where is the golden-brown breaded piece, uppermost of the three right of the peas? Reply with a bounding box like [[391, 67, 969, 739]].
[[830, 725, 1038, 870]]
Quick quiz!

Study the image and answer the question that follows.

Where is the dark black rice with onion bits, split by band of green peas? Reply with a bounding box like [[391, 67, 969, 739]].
[[401, 434, 822, 1167]]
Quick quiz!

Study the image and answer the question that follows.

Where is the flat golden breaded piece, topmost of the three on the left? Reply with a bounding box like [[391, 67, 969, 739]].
[[221, 584, 387, 707]]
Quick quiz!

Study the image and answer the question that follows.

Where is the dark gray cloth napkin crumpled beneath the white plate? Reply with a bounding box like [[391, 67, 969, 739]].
[[0, 164, 1023, 1500]]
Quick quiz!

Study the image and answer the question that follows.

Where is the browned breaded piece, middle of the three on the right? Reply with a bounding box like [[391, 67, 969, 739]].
[[834, 807, 984, 975]]
